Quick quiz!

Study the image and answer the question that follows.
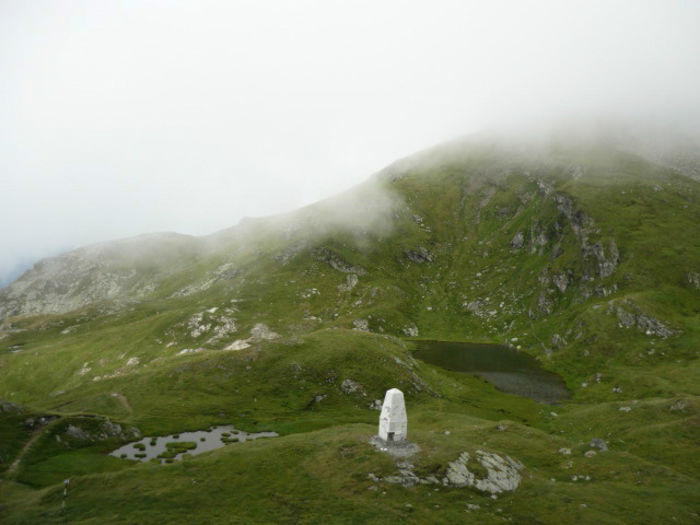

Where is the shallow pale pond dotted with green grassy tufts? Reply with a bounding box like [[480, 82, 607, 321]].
[[110, 426, 278, 463]]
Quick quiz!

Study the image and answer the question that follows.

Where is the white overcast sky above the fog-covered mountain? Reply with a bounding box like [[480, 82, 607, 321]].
[[0, 0, 700, 283]]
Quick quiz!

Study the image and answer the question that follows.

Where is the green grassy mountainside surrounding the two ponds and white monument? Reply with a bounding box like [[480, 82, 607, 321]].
[[0, 144, 700, 523]]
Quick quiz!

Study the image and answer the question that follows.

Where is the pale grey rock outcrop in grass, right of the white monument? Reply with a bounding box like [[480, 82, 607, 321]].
[[442, 450, 523, 494]]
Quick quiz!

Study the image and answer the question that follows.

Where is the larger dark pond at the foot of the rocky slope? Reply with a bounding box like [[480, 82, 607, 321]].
[[414, 341, 570, 404]]
